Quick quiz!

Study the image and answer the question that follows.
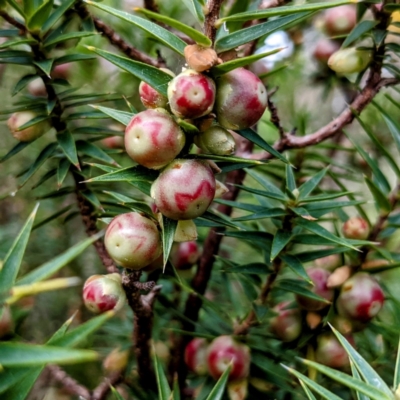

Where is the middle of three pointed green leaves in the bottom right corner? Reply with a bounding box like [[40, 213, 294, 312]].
[[302, 360, 393, 400]]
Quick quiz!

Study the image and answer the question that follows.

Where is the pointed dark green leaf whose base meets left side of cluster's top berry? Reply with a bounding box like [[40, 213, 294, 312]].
[[89, 47, 173, 96]]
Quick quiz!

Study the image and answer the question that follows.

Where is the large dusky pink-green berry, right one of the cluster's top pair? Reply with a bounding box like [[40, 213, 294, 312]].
[[215, 68, 267, 129]]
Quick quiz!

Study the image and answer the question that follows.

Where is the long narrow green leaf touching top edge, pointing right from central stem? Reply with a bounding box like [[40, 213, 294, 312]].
[[217, 0, 352, 25]]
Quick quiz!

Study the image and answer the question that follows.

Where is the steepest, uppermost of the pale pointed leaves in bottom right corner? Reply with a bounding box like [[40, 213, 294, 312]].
[[331, 327, 393, 400]]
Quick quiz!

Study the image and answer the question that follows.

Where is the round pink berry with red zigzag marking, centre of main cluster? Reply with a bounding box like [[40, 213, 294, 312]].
[[151, 159, 216, 220]]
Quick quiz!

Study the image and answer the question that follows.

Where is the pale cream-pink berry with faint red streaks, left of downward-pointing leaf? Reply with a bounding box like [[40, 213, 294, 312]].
[[104, 212, 162, 270]]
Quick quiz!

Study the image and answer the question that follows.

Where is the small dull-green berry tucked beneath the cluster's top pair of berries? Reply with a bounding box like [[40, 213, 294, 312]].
[[193, 125, 236, 156]]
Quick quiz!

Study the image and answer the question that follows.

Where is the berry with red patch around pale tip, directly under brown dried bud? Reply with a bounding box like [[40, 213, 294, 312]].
[[168, 69, 215, 119]]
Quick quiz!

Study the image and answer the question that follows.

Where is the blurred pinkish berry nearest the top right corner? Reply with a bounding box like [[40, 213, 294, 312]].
[[325, 5, 357, 36]]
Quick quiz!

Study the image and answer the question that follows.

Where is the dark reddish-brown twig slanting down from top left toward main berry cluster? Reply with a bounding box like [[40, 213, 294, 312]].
[[75, 2, 165, 68]]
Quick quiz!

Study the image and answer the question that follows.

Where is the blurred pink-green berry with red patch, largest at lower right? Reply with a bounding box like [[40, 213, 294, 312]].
[[336, 272, 385, 322]]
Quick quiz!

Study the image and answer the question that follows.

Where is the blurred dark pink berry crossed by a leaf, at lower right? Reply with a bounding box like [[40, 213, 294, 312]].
[[296, 268, 334, 311]]
